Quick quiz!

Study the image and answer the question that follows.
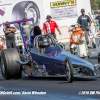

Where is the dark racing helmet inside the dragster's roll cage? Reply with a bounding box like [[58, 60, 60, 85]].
[[39, 37, 51, 48]]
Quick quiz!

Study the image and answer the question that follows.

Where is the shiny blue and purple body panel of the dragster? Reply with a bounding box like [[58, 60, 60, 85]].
[[30, 46, 97, 75]]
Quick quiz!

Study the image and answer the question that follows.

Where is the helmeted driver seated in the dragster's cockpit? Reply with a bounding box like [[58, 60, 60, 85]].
[[39, 36, 51, 54]]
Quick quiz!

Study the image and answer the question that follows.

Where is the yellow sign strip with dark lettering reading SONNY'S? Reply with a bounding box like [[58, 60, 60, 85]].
[[51, 0, 76, 8]]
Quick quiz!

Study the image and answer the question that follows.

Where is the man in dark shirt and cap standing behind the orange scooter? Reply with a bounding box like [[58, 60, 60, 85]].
[[77, 9, 92, 47]]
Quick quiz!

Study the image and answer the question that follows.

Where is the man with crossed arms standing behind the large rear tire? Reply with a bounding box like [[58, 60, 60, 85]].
[[3, 21, 16, 48]]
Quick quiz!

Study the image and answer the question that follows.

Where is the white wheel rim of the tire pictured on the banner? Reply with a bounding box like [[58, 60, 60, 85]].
[[27, 8, 37, 24]]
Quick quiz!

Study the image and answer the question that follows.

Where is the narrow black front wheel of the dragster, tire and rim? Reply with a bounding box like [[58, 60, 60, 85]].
[[65, 58, 74, 83]]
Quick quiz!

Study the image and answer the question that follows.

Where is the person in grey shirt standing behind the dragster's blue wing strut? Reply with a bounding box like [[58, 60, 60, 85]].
[[21, 18, 31, 43]]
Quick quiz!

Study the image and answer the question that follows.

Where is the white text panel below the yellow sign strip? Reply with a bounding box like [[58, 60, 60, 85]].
[[51, 5, 78, 20]]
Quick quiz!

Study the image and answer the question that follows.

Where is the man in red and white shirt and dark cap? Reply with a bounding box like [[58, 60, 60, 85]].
[[43, 15, 61, 38]]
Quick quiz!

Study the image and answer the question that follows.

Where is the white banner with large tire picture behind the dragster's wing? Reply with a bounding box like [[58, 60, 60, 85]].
[[0, 0, 44, 35]]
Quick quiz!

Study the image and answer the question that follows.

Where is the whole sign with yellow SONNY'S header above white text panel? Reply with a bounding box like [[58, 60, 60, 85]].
[[51, 0, 78, 20]]
